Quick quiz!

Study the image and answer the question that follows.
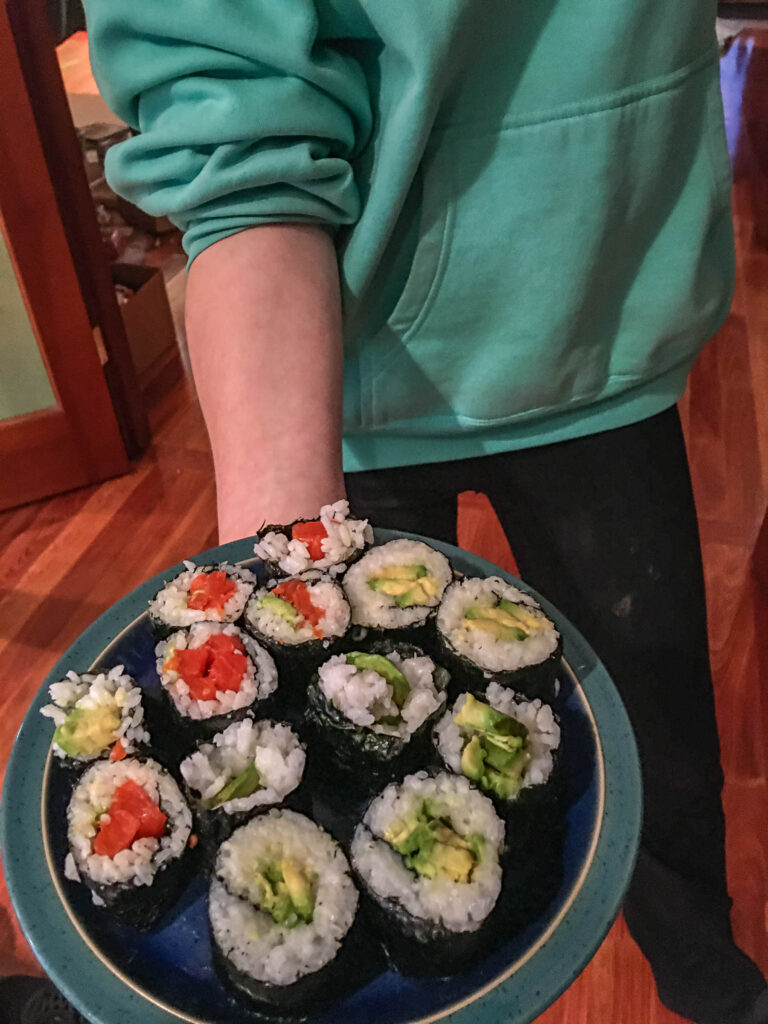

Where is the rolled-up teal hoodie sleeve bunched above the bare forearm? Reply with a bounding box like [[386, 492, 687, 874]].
[[85, 0, 371, 260]]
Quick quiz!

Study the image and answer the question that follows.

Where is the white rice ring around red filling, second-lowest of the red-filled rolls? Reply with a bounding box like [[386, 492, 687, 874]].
[[155, 623, 278, 721]]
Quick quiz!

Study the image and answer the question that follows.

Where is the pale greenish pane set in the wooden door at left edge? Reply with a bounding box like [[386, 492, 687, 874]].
[[0, 233, 56, 420]]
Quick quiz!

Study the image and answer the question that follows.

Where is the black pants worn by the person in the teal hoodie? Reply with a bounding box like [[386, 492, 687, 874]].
[[347, 409, 765, 1024]]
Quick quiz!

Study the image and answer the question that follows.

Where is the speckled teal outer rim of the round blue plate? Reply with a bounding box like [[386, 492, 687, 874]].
[[0, 528, 642, 1024]]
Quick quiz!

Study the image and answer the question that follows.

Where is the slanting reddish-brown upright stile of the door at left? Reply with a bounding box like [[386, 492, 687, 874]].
[[0, 3, 127, 479]]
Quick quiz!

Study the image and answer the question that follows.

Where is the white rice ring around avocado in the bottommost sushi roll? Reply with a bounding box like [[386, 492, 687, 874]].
[[208, 810, 357, 985]]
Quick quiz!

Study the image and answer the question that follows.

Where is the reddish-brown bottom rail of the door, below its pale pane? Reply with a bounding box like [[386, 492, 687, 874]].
[[0, 409, 91, 510]]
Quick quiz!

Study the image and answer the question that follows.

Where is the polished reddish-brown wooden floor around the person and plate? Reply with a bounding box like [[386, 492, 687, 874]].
[[0, 30, 768, 1024]]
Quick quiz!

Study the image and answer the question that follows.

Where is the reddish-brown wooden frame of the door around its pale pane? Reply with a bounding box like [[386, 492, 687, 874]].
[[0, 3, 128, 508]]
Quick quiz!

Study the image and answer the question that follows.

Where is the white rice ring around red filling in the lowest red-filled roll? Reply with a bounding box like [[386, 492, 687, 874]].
[[65, 758, 191, 886]]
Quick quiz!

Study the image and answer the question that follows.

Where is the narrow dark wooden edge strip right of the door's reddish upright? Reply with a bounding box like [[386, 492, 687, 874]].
[[5, 0, 150, 457]]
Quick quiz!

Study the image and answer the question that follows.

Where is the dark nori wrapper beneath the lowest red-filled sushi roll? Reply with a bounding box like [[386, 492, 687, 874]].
[[81, 846, 195, 932]]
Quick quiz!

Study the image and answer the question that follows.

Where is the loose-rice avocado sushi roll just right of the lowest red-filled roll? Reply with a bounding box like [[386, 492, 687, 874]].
[[179, 718, 306, 859]]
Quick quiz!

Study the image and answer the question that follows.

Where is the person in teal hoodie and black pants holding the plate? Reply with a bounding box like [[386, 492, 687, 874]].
[[63, 0, 768, 1024]]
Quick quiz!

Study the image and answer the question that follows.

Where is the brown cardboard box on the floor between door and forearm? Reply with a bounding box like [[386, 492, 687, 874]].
[[112, 263, 178, 379]]
